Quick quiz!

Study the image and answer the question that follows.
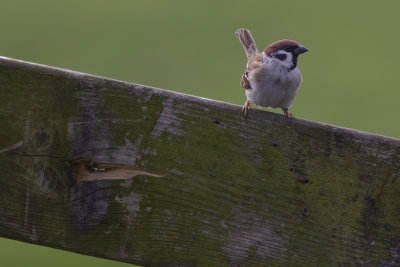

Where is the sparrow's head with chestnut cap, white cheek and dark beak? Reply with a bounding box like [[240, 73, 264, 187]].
[[263, 40, 308, 71]]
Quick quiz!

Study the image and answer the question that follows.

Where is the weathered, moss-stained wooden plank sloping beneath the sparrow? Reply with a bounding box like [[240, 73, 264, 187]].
[[0, 58, 400, 266]]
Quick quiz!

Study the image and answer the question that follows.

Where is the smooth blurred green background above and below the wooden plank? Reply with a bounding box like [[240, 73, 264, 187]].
[[0, 0, 400, 267]]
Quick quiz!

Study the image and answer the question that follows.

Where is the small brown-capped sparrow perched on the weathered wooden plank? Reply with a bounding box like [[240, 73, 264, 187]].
[[235, 28, 308, 118]]
